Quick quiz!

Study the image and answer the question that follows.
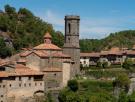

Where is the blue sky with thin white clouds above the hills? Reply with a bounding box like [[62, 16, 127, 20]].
[[0, 0, 135, 39]]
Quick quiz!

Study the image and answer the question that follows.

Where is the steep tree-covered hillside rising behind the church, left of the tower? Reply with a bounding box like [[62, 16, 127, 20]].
[[0, 5, 64, 57]]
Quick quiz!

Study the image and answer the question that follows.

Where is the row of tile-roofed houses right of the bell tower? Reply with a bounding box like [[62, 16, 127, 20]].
[[80, 46, 135, 66]]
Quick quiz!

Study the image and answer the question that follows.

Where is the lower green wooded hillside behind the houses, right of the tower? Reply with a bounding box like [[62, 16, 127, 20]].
[[80, 30, 135, 52]]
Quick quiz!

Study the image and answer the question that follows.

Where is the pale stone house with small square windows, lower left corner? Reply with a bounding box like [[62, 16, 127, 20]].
[[0, 64, 44, 102]]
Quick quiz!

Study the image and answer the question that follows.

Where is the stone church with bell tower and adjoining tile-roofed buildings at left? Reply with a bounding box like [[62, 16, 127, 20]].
[[0, 15, 80, 102]]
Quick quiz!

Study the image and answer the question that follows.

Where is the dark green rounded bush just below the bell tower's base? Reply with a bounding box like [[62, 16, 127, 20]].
[[68, 80, 79, 92]]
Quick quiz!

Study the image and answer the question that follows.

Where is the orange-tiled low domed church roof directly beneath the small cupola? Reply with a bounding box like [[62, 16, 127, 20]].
[[34, 43, 62, 50]]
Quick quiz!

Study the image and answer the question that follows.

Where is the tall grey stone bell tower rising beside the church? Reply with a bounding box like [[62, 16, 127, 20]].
[[63, 15, 80, 77]]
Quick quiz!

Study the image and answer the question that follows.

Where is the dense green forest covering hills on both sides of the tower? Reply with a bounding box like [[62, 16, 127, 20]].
[[0, 5, 135, 58]]
